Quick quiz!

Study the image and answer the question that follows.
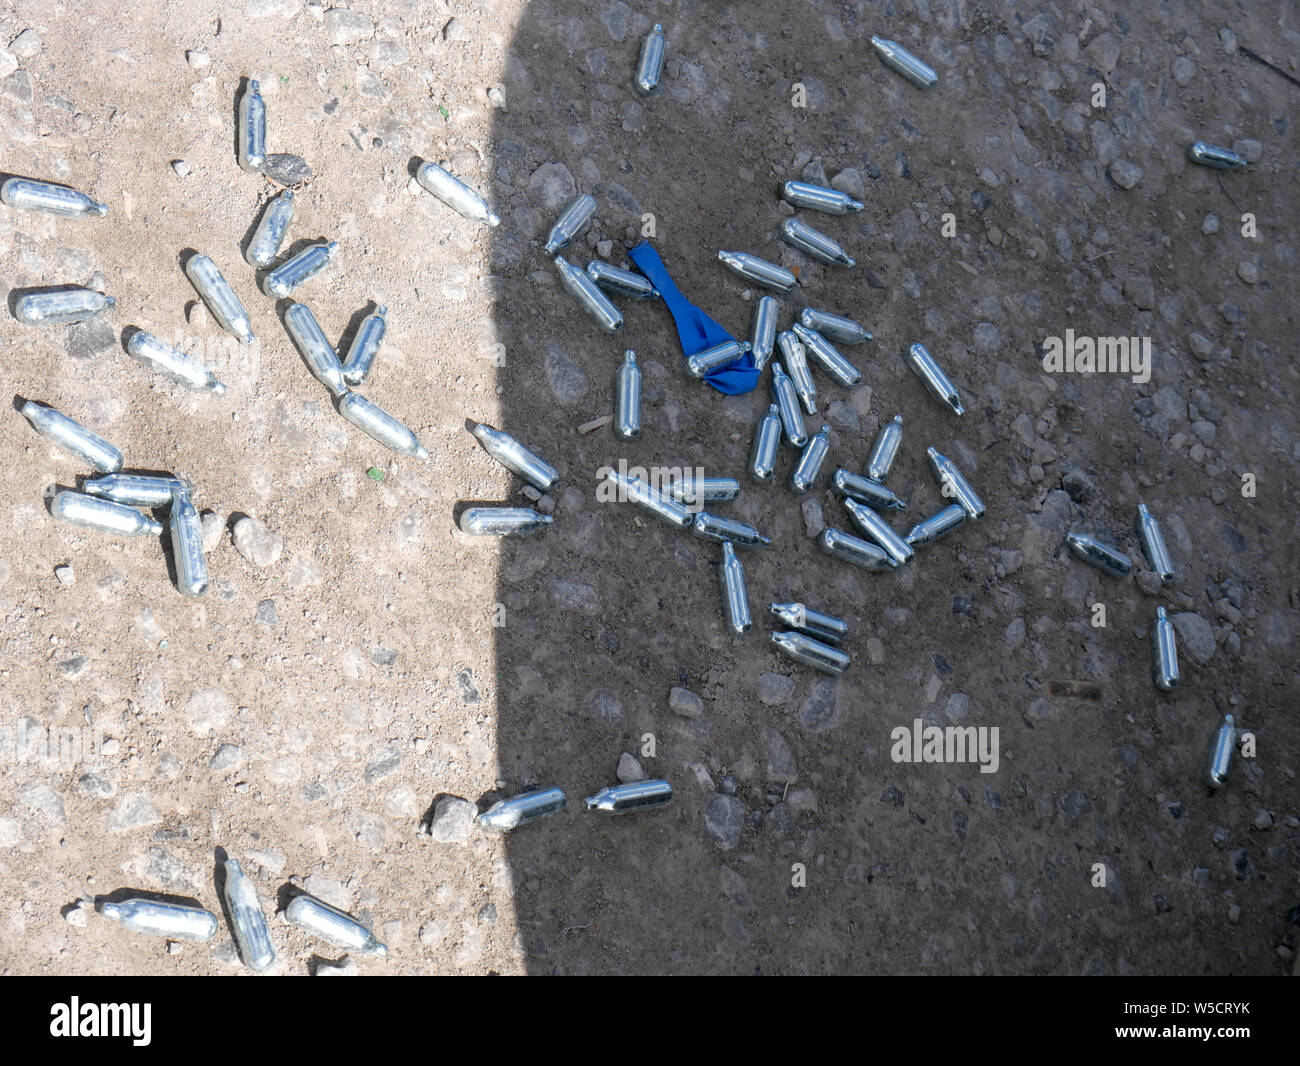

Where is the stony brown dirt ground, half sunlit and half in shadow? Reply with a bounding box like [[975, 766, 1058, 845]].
[[0, 0, 1300, 974]]
